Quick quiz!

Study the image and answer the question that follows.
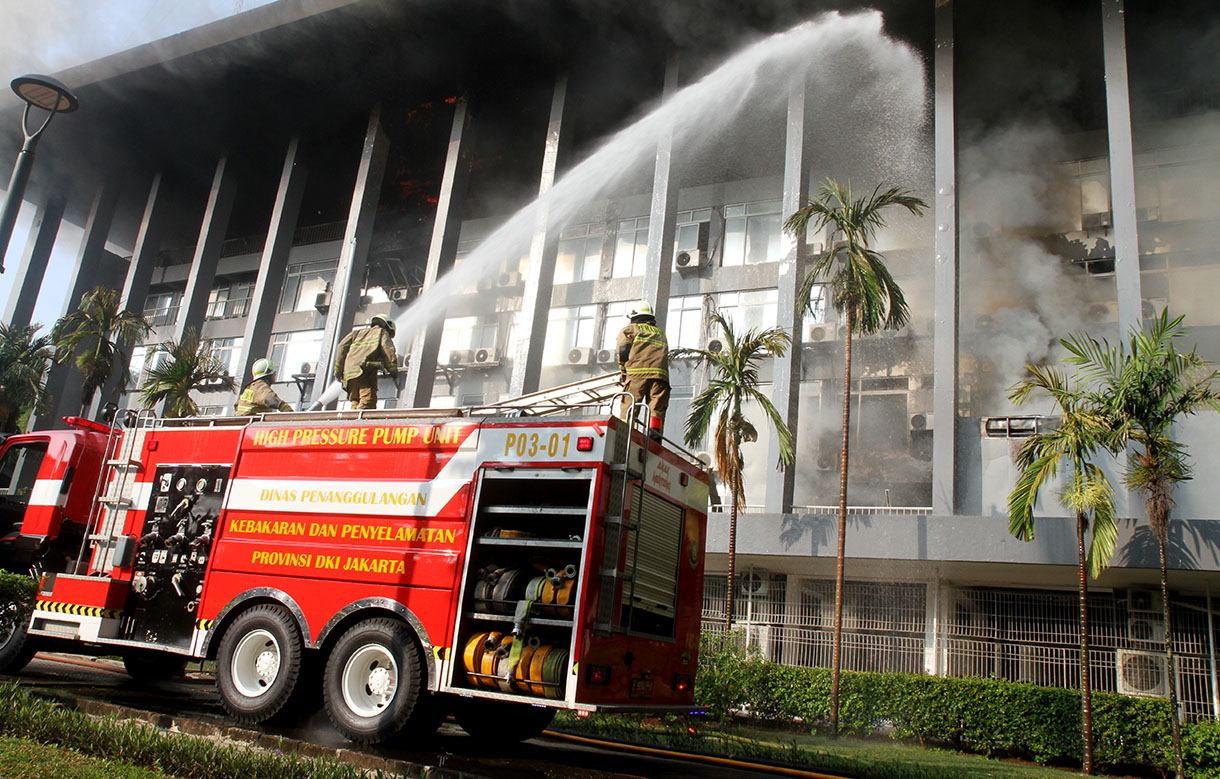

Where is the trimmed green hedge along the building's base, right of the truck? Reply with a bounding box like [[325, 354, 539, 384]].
[[695, 635, 1220, 779]]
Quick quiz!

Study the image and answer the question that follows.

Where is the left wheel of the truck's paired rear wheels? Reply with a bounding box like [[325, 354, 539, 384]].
[[216, 605, 304, 724]]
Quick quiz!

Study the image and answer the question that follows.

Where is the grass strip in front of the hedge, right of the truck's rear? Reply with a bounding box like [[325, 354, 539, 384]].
[[551, 713, 1078, 779]]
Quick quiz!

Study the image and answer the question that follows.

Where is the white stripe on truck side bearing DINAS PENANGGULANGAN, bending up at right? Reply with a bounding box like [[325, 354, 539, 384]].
[[226, 434, 482, 517]]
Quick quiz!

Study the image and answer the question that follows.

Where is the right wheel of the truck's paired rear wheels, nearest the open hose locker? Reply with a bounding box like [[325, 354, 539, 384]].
[[322, 619, 424, 744]]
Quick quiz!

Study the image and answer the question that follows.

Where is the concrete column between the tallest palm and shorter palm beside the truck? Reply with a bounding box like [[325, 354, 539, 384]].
[[765, 79, 809, 513]]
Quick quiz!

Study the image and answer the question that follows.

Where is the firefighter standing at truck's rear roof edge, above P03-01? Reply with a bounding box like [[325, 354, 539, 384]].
[[617, 301, 670, 439]]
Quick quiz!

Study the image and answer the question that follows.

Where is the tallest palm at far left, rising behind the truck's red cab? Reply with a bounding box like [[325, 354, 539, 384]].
[[51, 286, 153, 414]]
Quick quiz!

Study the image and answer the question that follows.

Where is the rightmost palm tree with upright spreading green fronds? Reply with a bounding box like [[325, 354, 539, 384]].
[[1064, 308, 1220, 777]]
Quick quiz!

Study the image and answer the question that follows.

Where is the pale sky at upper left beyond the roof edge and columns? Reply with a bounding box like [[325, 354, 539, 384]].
[[0, 0, 271, 325]]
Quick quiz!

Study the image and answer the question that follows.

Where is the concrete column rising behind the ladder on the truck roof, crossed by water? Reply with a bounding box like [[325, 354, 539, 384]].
[[509, 74, 567, 396]]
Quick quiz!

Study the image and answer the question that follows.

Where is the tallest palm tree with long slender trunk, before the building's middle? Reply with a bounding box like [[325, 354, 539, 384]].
[[783, 178, 927, 736]]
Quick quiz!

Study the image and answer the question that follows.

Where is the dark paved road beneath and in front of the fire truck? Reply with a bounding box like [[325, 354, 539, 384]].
[[7, 655, 790, 779]]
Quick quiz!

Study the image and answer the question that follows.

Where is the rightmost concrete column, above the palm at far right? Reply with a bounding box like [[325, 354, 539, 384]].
[[1102, 0, 1142, 340]]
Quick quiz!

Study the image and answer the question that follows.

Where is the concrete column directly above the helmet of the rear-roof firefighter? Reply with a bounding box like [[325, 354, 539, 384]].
[[644, 54, 678, 329]]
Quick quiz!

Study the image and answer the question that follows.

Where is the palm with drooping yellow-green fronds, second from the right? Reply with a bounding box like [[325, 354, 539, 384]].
[[1008, 366, 1118, 774]]
